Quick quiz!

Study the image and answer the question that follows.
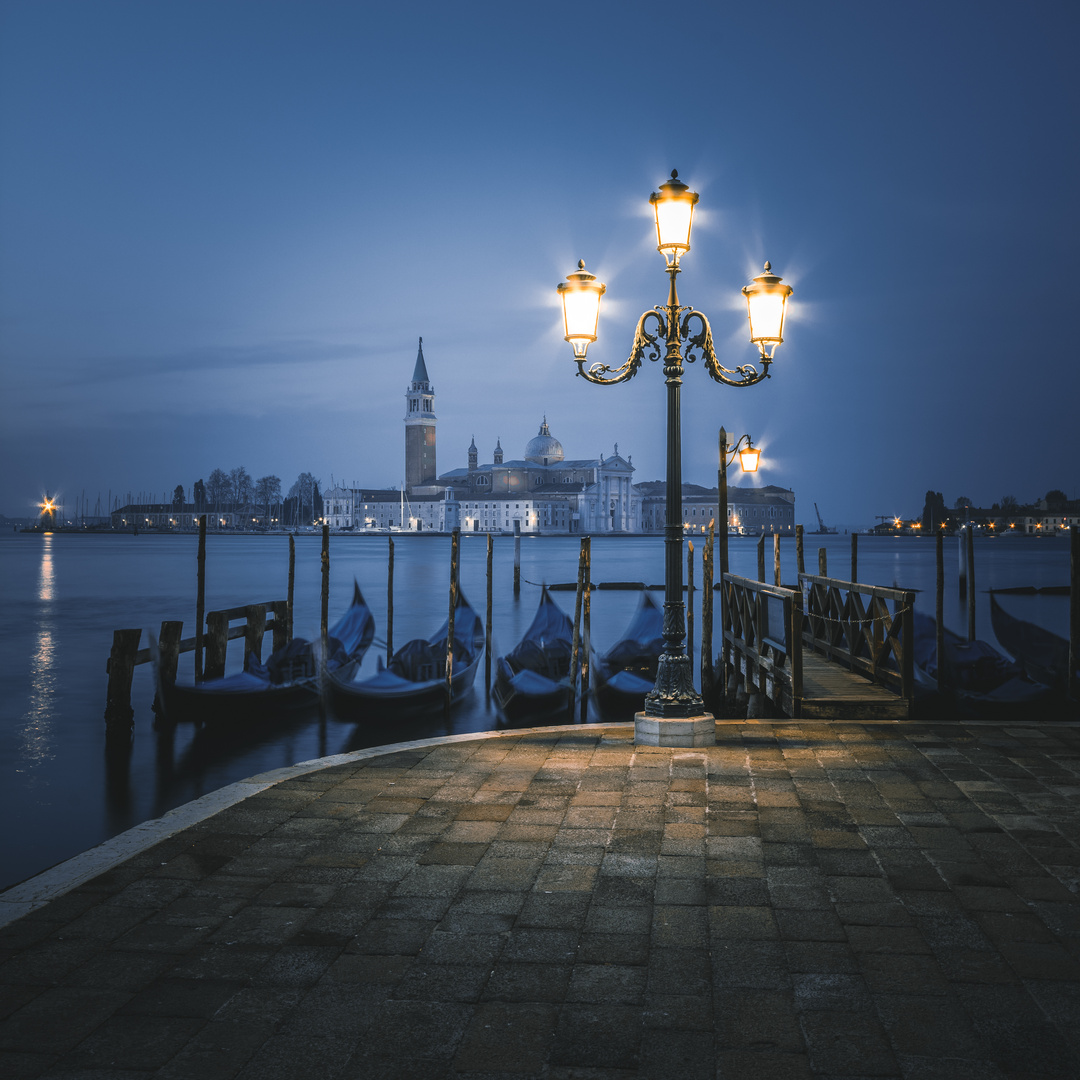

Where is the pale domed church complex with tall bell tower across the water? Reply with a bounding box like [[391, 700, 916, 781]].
[[323, 338, 795, 536]]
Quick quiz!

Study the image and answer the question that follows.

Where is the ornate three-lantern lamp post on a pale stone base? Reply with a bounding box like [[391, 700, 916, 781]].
[[558, 170, 792, 746]]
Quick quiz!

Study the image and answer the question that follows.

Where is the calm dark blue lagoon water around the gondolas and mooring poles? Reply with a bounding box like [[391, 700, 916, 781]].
[[0, 534, 1068, 888]]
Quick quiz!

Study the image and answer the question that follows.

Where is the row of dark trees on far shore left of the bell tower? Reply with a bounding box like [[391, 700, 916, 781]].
[[173, 465, 323, 528]]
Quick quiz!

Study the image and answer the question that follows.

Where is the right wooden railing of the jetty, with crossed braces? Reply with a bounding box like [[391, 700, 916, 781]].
[[799, 573, 915, 702]]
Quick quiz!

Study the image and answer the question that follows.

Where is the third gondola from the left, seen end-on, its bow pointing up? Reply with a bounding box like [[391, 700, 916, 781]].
[[492, 586, 573, 720]]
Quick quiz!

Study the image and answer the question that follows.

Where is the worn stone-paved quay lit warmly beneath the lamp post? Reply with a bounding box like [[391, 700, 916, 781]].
[[0, 721, 1080, 1080]]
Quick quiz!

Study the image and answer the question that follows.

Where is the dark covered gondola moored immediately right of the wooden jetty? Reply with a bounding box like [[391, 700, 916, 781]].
[[913, 611, 1051, 718]]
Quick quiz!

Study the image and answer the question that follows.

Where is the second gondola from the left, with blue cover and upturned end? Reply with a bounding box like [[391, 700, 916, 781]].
[[327, 591, 484, 719]]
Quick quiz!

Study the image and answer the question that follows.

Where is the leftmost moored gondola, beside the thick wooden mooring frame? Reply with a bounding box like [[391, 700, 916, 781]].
[[156, 581, 375, 724]]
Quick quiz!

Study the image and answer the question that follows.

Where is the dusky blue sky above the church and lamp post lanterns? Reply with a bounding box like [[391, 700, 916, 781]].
[[0, 0, 1080, 527]]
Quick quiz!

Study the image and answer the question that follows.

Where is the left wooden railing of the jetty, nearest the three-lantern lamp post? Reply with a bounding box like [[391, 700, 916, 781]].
[[720, 573, 802, 718]]
